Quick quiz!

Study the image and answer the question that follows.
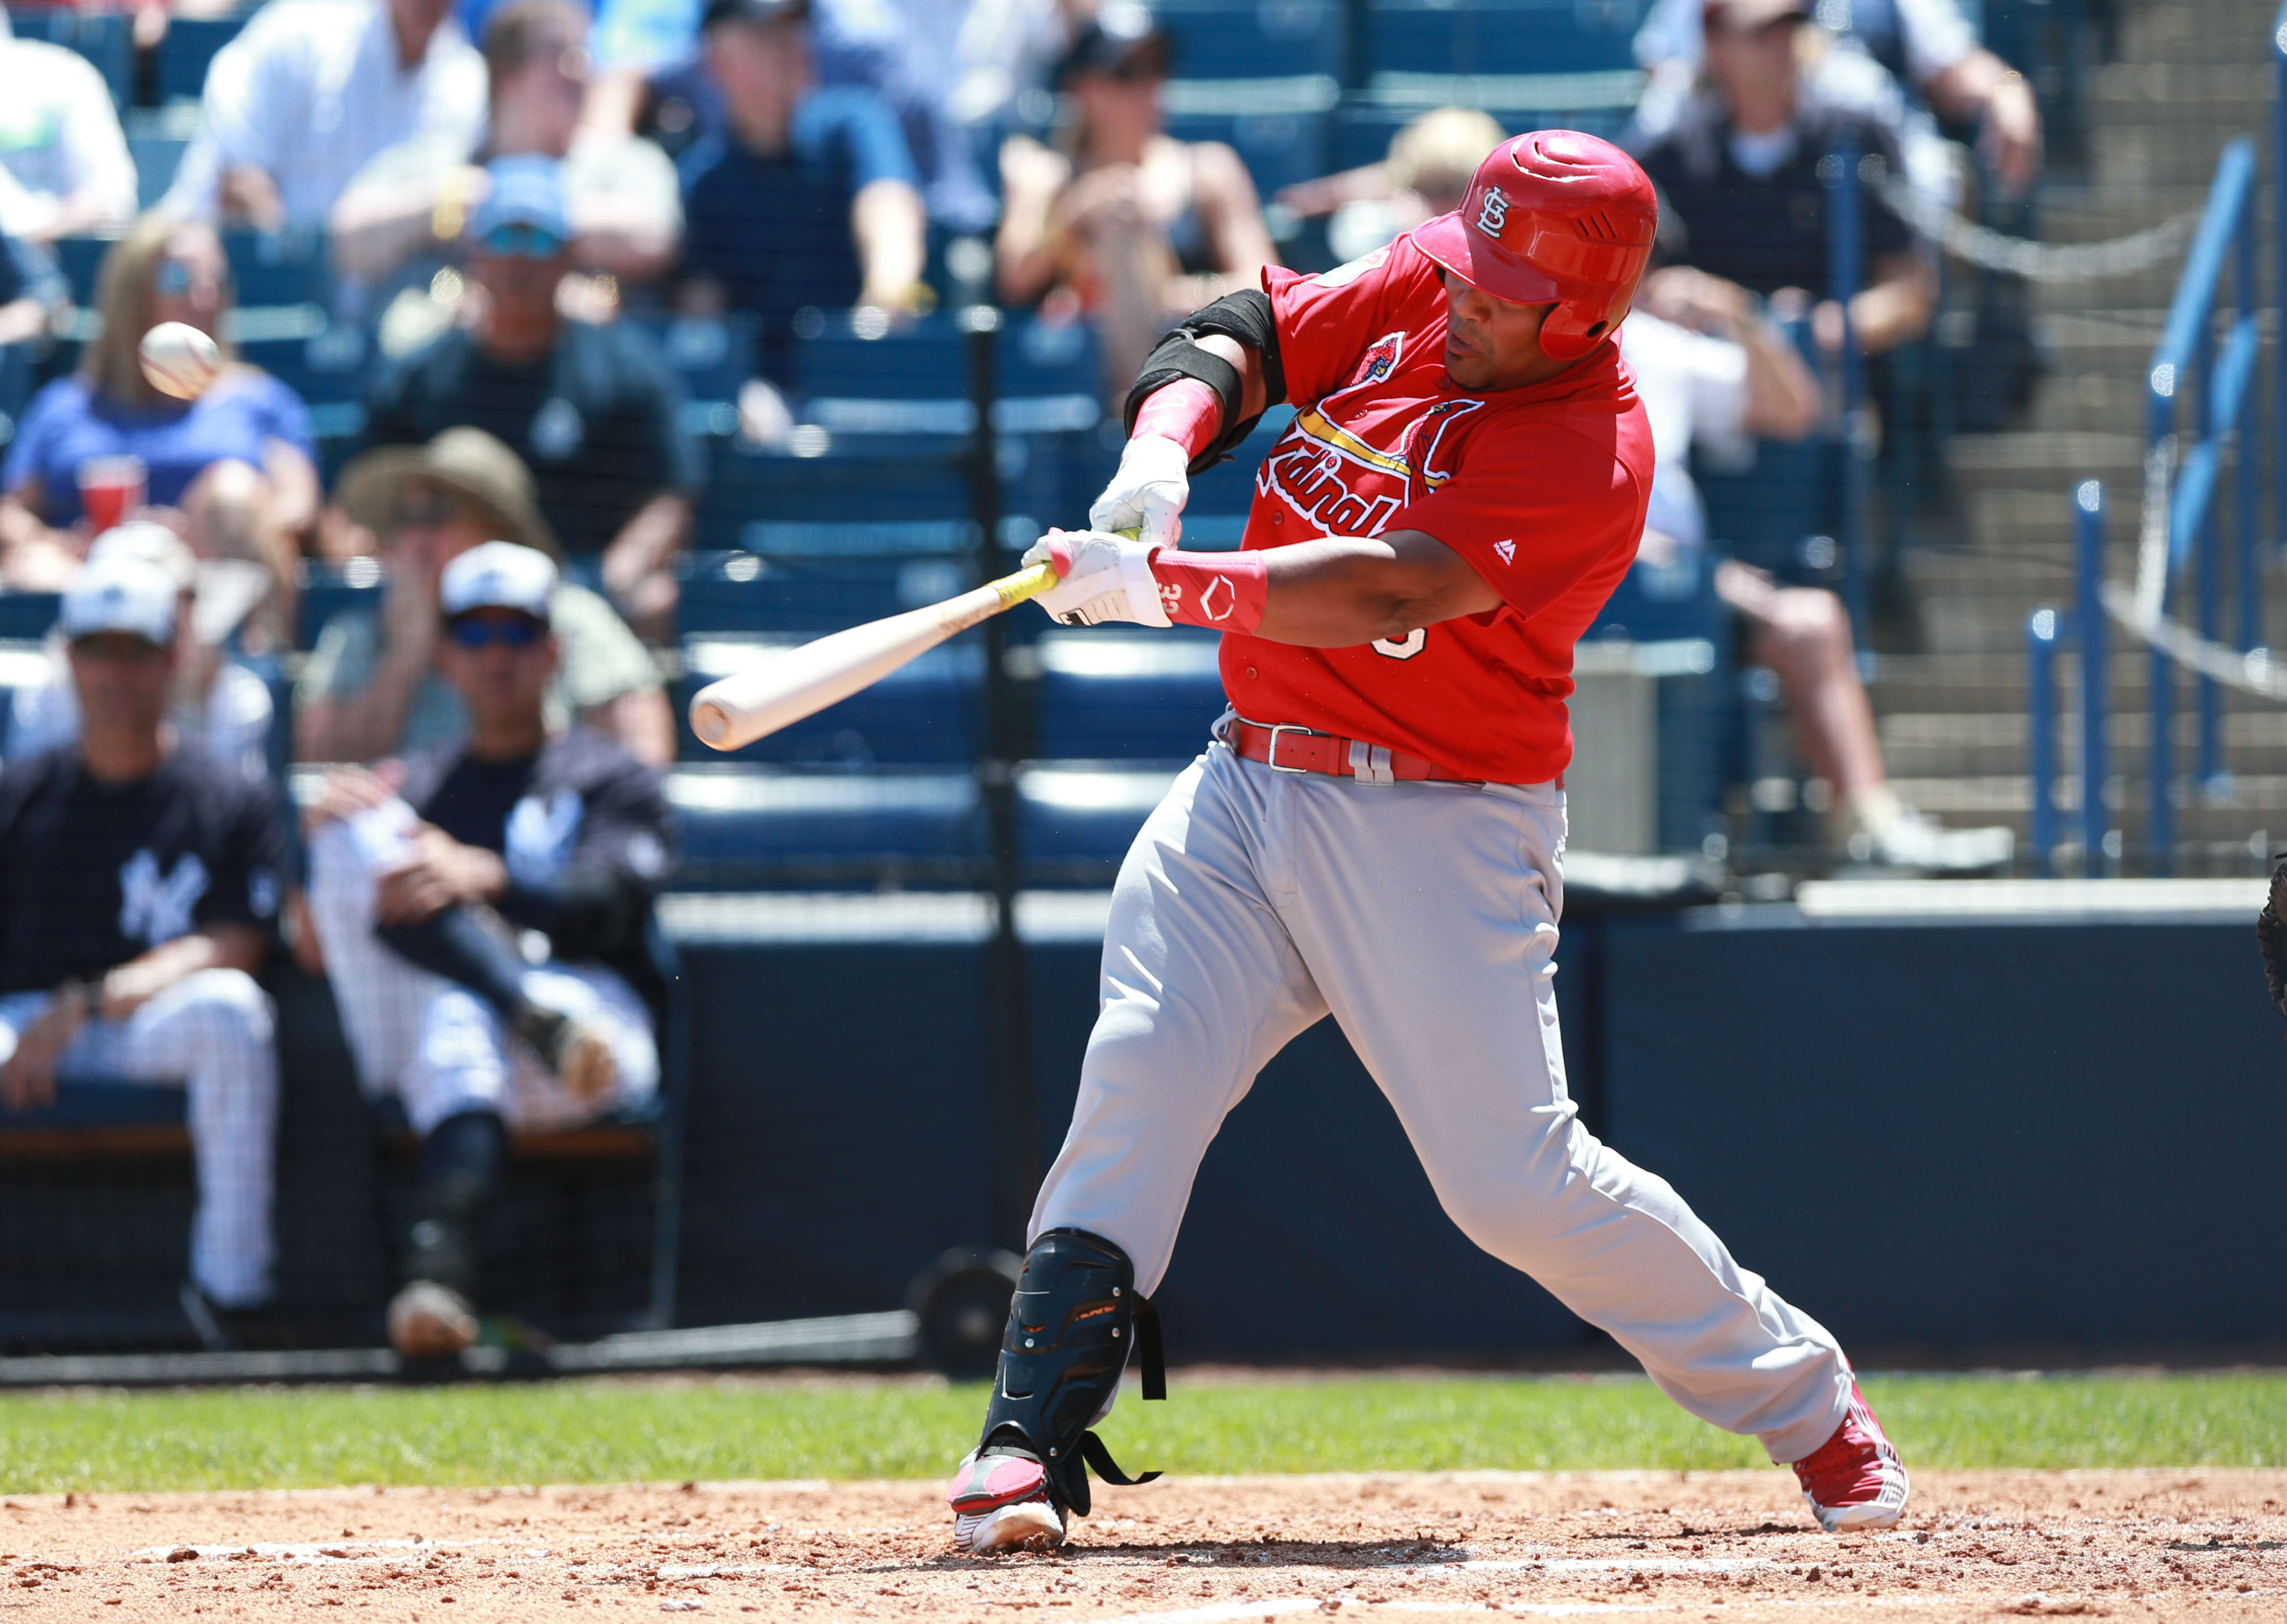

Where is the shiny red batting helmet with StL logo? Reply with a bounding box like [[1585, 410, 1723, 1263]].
[[1414, 130, 1660, 362]]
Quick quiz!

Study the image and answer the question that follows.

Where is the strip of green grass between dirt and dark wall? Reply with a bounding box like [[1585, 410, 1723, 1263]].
[[0, 1372, 2287, 1494]]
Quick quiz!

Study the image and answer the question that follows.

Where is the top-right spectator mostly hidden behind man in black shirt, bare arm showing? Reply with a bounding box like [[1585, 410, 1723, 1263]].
[[1635, 0, 2040, 203]]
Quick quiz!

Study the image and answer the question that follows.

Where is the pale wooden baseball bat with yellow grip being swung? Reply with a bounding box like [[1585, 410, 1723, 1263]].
[[691, 563, 1056, 750]]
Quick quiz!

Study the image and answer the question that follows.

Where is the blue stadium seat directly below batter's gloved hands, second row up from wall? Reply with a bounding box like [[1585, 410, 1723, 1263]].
[[1032, 627, 1224, 762]]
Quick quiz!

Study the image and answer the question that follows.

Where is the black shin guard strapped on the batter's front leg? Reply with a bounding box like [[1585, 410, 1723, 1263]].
[[981, 1228, 1166, 1516]]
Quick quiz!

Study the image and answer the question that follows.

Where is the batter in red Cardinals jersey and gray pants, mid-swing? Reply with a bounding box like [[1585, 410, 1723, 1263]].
[[949, 130, 1907, 1553]]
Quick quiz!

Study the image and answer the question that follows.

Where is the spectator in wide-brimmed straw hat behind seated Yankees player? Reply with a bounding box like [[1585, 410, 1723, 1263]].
[[295, 428, 674, 766]]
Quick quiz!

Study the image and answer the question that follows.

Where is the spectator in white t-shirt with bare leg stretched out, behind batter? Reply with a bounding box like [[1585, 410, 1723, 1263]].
[[1619, 265, 2010, 874]]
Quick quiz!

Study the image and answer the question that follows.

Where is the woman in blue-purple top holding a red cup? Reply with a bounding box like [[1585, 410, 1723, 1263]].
[[0, 213, 318, 652]]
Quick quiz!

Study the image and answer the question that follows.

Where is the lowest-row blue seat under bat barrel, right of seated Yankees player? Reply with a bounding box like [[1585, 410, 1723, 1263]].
[[668, 762, 983, 890]]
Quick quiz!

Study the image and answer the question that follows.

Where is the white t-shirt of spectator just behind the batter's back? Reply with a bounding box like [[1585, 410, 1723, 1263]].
[[1619, 311, 1754, 551]]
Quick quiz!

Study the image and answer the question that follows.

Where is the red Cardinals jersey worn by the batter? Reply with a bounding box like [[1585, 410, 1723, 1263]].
[[1221, 238, 1651, 785]]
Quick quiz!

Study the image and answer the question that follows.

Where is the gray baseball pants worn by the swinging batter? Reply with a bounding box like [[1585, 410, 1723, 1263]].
[[1032, 743, 1850, 1462]]
